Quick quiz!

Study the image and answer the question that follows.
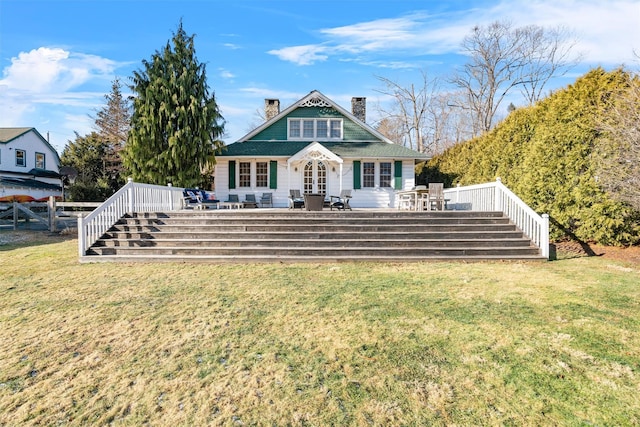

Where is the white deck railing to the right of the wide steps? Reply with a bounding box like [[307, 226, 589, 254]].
[[444, 178, 549, 258]]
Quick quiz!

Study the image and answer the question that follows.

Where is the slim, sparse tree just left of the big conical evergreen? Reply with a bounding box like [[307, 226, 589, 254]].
[[95, 77, 131, 192]]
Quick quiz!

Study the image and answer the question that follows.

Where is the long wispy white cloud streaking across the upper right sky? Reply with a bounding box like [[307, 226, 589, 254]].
[[268, 0, 640, 68]]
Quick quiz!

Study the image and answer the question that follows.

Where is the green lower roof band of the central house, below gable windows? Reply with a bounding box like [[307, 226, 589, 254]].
[[216, 141, 429, 159]]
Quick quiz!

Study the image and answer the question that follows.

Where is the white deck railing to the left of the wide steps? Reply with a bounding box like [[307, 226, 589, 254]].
[[78, 180, 183, 257]]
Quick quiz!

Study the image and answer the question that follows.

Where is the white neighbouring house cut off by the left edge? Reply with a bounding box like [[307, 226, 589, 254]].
[[0, 127, 62, 202]]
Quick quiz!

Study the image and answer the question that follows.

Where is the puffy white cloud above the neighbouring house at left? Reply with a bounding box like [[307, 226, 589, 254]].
[[0, 47, 122, 151]]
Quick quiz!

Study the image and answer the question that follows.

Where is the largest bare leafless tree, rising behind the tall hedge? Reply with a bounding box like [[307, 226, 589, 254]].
[[451, 21, 575, 136]]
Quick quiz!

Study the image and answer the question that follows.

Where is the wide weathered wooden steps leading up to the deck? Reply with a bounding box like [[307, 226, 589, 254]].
[[81, 209, 545, 262]]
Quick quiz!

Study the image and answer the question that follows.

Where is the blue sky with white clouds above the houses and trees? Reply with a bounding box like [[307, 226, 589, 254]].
[[0, 0, 640, 152]]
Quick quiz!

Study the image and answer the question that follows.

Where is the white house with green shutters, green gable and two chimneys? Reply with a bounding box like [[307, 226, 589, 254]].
[[215, 91, 428, 208]]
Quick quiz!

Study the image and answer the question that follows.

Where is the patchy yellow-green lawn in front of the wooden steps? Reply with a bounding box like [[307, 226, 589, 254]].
[[0, 237, 640, 426]]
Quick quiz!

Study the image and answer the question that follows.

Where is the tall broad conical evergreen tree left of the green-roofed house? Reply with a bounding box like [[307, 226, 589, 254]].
[[123, 22, 224, 187]]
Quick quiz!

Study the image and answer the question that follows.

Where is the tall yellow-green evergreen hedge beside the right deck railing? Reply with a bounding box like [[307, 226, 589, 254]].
[[418, 68, 640, 245]]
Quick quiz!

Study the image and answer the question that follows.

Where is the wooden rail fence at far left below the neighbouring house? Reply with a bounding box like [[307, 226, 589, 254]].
[[0, 196, 101, 232]]
